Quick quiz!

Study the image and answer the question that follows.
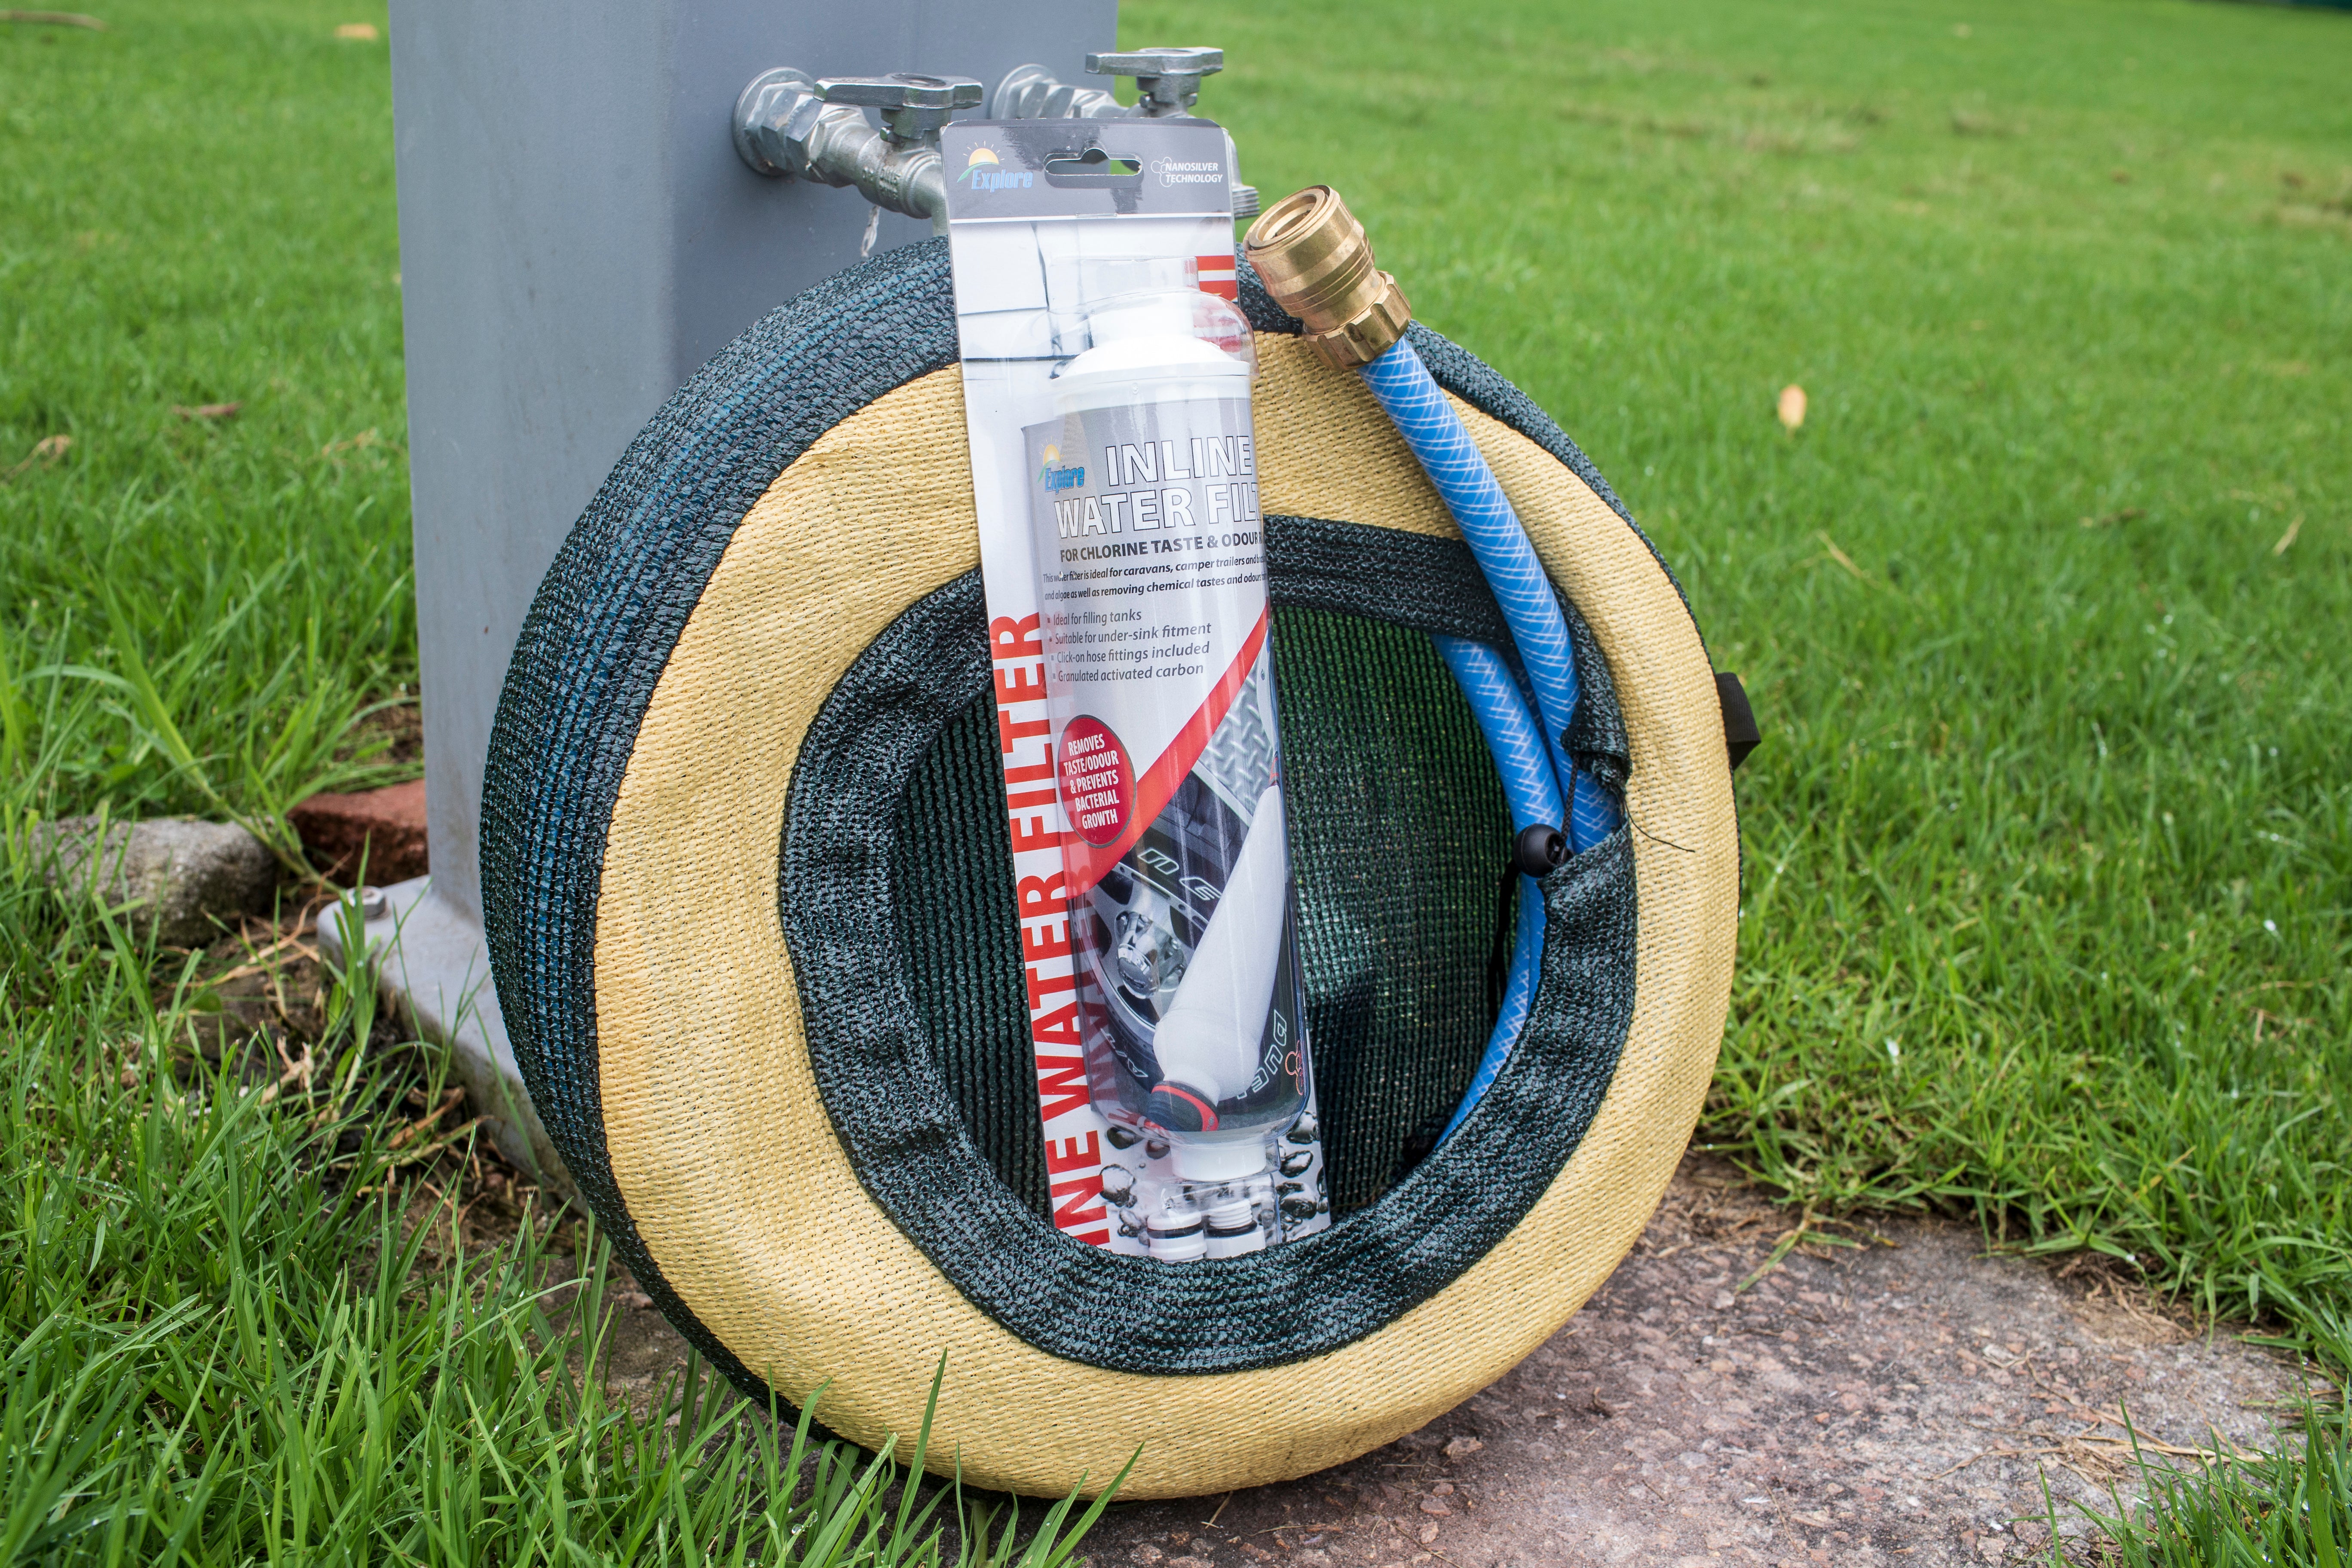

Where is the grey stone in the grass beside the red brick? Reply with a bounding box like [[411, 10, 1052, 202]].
[[31, 816, 278, 947]]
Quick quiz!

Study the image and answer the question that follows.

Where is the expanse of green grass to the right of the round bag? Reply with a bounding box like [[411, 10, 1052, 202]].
[[1127, 0, 2352, 1363]]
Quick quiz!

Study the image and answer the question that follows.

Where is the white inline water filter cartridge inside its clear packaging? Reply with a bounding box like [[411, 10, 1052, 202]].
[[1026, 261, 1312, 1260]]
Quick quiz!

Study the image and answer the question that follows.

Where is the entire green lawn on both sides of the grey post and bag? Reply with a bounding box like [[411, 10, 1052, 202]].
[[0, 0, 2352, 1561]]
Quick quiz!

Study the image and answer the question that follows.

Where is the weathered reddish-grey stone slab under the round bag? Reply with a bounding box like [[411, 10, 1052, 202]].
[[1087, 1159, 2300, 1568]]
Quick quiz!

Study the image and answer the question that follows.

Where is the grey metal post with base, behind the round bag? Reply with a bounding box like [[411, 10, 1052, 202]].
[[320, 0, 1117, 1180]]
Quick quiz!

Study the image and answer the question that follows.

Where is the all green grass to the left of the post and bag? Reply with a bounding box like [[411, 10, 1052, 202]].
[[0, 2, 1129, 1568]]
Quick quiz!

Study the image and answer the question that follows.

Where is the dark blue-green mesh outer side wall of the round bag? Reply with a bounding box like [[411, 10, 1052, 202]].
[[482, 240, 1656, 1394]]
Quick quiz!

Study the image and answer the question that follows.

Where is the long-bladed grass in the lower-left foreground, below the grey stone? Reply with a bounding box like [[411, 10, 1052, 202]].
[[0, 888, 1108, 1568]]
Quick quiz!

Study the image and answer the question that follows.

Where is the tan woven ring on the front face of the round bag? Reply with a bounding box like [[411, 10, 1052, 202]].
[[595, 336, 1736, 1498]]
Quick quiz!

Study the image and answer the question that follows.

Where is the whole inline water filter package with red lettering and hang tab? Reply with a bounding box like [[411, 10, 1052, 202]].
[[943, 120, 1331, 1262]]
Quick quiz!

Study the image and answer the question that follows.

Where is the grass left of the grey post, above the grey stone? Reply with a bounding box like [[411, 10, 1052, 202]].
[[0, 2, 416, 846]]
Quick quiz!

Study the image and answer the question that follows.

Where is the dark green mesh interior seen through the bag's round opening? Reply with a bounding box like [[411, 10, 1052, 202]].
[[891, 517, 1625, 1218]]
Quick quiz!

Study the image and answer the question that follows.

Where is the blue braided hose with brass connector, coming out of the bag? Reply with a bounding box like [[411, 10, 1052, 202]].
[[1244, 186, 1618, 1142]]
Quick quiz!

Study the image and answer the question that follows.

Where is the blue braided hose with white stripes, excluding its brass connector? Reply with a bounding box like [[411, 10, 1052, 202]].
[[1362, 341, 1618, 1138]]
